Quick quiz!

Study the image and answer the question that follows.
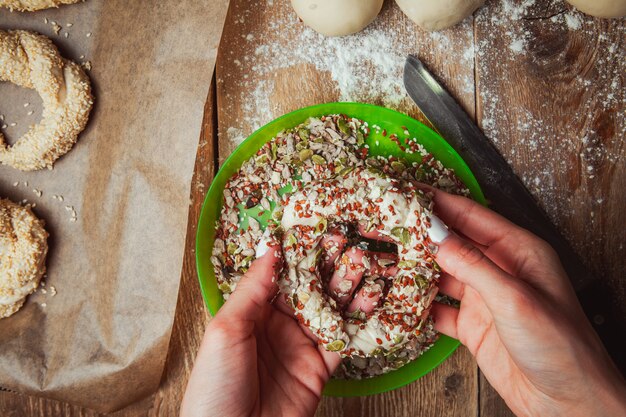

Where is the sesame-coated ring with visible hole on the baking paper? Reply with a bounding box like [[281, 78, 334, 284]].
[[0, 30, 93, 171]]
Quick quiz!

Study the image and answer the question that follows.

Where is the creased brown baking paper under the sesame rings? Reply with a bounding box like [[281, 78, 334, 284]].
[[0, 0, 228, 411]]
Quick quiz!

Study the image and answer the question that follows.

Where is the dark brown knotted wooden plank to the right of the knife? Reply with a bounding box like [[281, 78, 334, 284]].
[[475, 0, 626, 416]]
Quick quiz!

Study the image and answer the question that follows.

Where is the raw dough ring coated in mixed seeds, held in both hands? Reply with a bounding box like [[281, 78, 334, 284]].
[[280, 167, 438, 357]]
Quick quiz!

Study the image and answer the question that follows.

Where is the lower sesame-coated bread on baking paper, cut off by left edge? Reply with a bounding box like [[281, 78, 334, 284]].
[[0, 199, 48, 319]]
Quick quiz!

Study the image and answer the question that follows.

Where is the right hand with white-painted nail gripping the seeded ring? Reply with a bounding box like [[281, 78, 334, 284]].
[[431, 190, 626, 417]]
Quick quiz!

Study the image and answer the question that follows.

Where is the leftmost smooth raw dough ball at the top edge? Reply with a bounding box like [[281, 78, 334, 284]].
[[291, 0, 383, 36]]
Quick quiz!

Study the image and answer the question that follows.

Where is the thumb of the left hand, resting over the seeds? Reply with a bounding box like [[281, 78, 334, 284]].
[[217, 245, 282, 320]]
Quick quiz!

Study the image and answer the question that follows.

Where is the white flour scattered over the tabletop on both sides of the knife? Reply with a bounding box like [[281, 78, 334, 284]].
[[218, 0, 626, 258]]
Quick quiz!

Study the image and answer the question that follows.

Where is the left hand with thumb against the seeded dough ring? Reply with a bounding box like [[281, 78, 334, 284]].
[[181, 248, 340, 417]]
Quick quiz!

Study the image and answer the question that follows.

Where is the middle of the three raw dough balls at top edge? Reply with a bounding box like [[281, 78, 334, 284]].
[[396, 0, 485, 30]]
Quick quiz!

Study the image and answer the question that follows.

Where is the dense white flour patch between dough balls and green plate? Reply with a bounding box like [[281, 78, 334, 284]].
[[218, 4, 474, 138]]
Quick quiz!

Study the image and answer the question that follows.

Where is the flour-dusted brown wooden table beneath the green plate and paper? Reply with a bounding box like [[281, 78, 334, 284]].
[[0, 0, 626, 417]]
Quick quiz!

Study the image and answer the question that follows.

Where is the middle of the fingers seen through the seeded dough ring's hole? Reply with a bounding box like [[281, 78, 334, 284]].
[[328, 247, 368, 306]]
